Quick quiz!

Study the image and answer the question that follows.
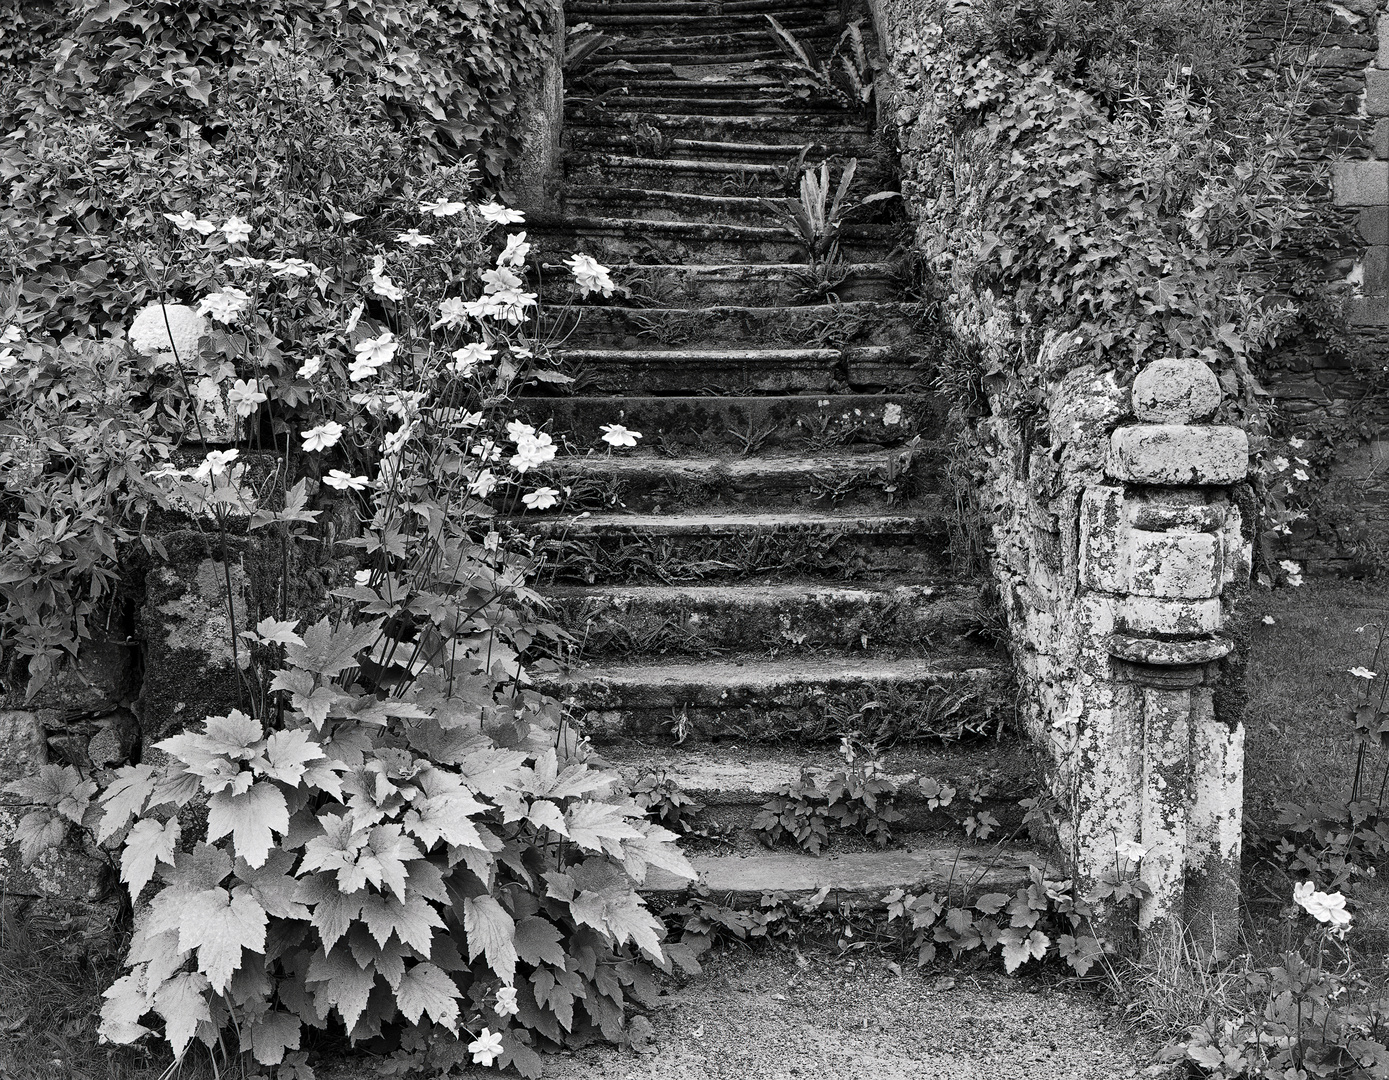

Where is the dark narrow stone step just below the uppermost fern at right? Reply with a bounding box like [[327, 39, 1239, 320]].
[[564, 101, 874, 138]]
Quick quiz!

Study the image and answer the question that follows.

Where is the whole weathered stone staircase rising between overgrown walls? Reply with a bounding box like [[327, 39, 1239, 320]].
[[518, 0, 1035, 902]]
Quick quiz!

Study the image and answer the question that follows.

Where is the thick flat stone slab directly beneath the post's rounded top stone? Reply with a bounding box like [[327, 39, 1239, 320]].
[[1106, 423, 1249, 484]]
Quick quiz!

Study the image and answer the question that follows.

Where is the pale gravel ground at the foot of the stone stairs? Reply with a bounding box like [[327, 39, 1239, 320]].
[[319, 950, 1168, 1080]]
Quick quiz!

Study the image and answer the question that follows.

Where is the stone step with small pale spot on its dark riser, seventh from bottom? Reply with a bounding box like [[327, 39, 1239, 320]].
[[518, 394, 946, 453]]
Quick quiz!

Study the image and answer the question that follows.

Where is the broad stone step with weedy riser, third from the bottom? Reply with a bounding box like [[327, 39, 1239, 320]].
[[533, 651, 1011, 743]]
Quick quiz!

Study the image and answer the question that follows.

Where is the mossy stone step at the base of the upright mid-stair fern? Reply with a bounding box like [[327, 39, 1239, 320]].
[[542, 262, 901, 311]]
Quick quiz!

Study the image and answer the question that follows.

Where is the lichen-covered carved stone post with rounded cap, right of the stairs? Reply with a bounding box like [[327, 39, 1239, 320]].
[[1081, 353, 1250, 952]]
